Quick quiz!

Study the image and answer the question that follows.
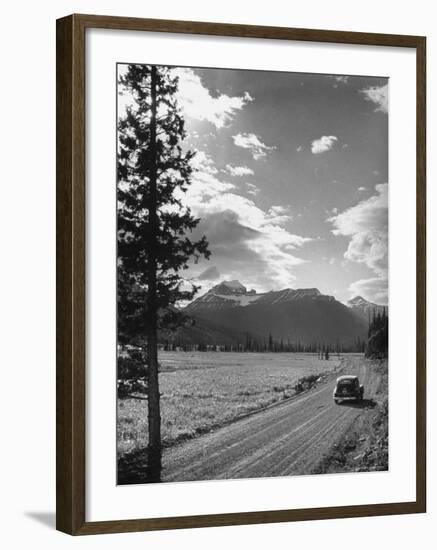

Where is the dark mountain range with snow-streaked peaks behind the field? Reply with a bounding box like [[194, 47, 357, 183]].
[[162, 280, 383, 345]]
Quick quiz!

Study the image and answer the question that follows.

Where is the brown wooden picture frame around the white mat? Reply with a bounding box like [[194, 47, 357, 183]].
[[56, 15, 426, 535]]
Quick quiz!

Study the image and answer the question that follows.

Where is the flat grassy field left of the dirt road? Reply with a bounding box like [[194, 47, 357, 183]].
[[117, 352, 340, 456]]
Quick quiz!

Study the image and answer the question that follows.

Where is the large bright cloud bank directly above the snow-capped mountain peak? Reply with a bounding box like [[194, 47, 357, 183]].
[[178, 157, 312, 291]]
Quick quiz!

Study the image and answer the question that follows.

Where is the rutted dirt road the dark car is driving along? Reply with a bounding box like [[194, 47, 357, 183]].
[[162, 358, 380, 481]]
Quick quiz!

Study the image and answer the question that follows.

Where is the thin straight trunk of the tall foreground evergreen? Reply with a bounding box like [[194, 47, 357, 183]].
[[147, 65, 162, 482]]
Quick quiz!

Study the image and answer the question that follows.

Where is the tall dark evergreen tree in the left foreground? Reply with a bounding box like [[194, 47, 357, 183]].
[[117, 65, 209, 481]]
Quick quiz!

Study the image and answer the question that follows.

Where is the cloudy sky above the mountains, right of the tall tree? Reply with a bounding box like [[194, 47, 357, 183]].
[[117, 68, 388, 304]]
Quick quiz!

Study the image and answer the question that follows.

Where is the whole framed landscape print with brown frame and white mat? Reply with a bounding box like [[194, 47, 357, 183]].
[[57, 15, 426, 535]]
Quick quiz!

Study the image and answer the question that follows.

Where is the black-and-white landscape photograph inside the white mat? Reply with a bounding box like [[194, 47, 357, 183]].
[[114, 59, 389, 485]]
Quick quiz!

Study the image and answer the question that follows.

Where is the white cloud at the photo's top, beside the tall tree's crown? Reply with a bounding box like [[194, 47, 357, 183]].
[[173, 68, 253, 129]]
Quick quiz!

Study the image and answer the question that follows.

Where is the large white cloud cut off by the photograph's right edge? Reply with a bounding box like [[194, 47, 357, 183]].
[[328, 183, 388, 301]]
